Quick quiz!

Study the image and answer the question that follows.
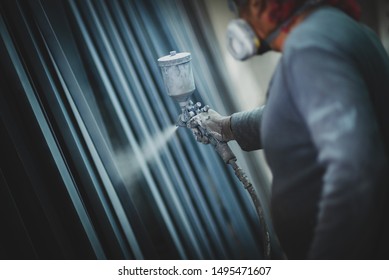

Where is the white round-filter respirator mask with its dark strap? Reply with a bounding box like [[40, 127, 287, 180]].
[[226, 0, 323, 61]]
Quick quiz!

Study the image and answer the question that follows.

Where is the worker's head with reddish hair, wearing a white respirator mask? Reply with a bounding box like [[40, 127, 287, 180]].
[[227, 0, 360, 60]]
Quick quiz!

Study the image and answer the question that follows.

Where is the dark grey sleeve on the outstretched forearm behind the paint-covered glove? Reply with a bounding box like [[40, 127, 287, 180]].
[[231, 106, 264, 151]]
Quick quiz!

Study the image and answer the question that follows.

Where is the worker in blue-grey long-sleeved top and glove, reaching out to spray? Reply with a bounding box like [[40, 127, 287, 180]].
[[189, 0, 389, 259]]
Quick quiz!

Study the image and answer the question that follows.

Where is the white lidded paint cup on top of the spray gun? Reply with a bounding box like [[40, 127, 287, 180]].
[[158, 51, 196, 108]]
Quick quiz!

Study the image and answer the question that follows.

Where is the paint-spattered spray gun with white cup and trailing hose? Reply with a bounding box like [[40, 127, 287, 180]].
[[158, 51, 271, 259]]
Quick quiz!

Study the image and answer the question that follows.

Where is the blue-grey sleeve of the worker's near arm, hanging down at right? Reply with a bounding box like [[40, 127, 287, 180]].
[[283, 47, 388, 259]]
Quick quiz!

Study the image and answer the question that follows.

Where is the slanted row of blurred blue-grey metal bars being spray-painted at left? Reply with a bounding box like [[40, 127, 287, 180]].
[[0, 0, 270, 259]]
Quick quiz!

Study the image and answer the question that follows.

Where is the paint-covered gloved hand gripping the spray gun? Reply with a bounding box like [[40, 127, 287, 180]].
[[187, 109, 234, 144]]
